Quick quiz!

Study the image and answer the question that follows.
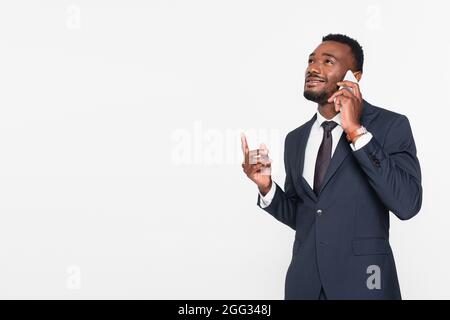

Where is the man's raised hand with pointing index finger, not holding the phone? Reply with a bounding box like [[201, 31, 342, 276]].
[[241, 134, 272, 196]]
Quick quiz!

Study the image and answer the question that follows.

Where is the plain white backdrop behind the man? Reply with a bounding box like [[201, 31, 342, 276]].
[[0, 0, 450, 299]]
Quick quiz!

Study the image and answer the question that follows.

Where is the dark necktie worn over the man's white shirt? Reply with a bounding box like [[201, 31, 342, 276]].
[[314, 121, 337, 195]]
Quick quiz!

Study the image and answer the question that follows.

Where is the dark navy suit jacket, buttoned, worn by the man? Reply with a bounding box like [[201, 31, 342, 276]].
[[258, 101, 422, 299]]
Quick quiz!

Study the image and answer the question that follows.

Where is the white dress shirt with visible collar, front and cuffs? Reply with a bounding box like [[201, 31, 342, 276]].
[[260, 110, 372, 208]]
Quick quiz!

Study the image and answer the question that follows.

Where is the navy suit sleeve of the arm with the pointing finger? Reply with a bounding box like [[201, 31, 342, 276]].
[[257, 135, 300, 230]]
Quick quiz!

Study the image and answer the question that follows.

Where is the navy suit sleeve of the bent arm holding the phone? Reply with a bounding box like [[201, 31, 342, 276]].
[[353, 116, 422, 220]]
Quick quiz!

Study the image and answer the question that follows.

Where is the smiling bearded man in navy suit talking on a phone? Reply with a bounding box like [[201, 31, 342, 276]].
[[242, 34, 422, 299]]
